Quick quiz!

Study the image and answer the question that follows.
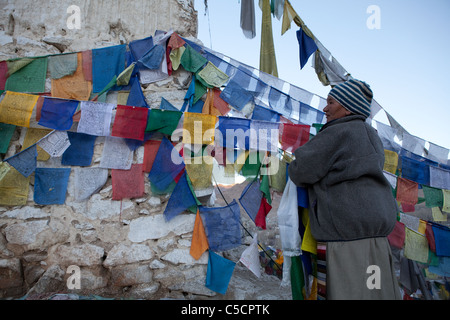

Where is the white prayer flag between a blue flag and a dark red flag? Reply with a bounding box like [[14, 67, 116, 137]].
[[77, 101, 115, 136]]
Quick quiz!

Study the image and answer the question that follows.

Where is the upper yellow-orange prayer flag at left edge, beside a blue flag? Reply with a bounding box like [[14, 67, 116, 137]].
[[0, 91, 39, 128]]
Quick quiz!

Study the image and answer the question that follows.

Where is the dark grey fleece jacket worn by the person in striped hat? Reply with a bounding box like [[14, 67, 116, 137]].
[[288, 115, 398, 241]]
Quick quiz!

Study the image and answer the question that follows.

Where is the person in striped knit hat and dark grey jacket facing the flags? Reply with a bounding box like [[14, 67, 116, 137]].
[[288, 79, 401, 299]]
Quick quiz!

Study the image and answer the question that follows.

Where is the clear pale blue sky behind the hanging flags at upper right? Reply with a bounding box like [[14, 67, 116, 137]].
[[195, 0, 450, 149]]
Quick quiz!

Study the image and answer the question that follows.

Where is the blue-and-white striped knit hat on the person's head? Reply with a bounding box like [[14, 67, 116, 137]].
[[329, 79, 373, 118]]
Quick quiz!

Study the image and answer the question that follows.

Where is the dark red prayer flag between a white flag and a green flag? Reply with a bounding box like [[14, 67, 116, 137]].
[[111, 105, 149, 141]]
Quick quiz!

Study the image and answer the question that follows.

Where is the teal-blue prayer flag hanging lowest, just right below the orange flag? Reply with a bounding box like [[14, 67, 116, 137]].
[[205, 249, 236, 294]]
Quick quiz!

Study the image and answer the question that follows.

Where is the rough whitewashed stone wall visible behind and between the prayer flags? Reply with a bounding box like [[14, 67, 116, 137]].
[[0, 0, 290, 299]]
